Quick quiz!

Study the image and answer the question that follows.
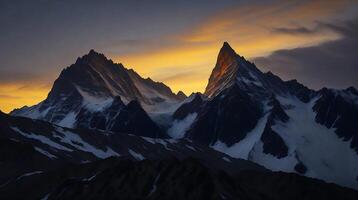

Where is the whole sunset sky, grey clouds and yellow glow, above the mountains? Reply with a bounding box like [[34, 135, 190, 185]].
[[0, 0, 358, 112]]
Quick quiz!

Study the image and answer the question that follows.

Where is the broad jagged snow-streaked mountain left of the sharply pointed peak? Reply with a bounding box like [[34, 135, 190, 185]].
[[11, 50, 184, 136]]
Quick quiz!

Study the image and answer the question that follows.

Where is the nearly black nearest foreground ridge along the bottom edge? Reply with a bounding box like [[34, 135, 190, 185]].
[[1, 158, 358, 200]]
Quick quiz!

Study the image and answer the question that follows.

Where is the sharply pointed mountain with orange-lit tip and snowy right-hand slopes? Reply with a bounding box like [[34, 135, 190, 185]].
[[179, 43, 358, 188]]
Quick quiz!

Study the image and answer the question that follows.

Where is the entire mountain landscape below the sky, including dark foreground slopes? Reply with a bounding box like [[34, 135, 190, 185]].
[[0, 42, 358, 199]]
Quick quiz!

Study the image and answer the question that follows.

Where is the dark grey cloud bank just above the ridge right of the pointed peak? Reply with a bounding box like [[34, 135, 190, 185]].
[[254, 18, 358, 89]]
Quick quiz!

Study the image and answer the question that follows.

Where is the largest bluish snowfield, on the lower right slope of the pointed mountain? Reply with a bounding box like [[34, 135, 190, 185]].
[[251, 97, 358, 188]]
